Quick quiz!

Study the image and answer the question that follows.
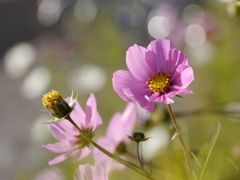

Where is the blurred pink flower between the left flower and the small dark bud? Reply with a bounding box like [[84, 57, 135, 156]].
[[93, 103, 136, 174]]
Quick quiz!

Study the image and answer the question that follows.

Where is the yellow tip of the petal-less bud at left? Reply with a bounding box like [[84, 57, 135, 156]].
[[42, 90, 62, 109]]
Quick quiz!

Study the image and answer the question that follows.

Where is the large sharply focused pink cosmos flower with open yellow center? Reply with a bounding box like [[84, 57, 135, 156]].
[[113, 39, 194, 111]]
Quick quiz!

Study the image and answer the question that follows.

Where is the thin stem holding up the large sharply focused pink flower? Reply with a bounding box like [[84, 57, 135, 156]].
[[167, 104, 192, 180]]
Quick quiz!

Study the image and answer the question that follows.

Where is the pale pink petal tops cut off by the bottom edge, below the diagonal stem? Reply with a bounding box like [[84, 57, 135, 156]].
[[74, 164, 108, 180]]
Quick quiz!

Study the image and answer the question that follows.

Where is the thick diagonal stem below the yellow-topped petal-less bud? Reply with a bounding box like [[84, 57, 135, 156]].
[[66, 116, 154, 180]]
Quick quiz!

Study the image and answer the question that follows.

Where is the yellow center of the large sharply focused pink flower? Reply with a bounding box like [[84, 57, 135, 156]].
[[146, 71, 172, 93]]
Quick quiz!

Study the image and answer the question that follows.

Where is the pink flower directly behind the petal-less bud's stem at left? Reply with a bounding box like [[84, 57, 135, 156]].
[[42, 94, 102, 165]]
